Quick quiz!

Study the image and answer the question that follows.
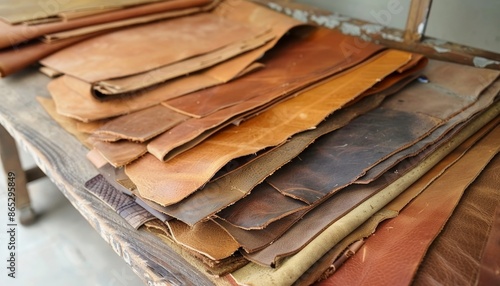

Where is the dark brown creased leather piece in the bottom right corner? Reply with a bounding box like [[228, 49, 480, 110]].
[[414, 155, 500, 285]]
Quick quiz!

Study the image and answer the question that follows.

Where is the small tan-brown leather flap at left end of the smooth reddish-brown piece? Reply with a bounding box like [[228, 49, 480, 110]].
[[94, 105, 189, 142]]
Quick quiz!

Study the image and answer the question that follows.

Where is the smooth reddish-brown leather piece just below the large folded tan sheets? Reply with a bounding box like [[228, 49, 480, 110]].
[[165, 28, 382, 117]]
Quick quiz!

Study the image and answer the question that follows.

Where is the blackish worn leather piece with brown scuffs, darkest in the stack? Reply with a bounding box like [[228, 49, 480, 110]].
[[266, 107, 442, 204]]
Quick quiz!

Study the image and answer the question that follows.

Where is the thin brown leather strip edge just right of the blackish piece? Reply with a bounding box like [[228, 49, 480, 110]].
[[355, 77, 500, 184]]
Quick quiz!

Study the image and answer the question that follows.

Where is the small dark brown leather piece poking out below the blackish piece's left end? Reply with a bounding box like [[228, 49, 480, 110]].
[[217, 183, 307, 230]]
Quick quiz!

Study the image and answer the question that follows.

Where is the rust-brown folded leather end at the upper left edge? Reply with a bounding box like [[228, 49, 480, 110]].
[[0, 34, 95, 77]]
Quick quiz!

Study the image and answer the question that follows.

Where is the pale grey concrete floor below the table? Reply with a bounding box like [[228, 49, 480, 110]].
[[0, 142, 143, 286]]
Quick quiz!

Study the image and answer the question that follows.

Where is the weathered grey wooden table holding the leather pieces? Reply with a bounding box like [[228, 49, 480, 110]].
[[0, 66, 219, 285]]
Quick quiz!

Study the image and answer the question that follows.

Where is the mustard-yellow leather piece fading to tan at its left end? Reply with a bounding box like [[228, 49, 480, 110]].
[[125, 50, 411, 205]]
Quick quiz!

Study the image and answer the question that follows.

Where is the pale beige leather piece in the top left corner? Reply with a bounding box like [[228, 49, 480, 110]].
[[0, 0, 167, 23]]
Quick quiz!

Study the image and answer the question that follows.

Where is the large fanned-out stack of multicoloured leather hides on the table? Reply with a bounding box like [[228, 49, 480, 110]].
[[19, 0, 500, 285]]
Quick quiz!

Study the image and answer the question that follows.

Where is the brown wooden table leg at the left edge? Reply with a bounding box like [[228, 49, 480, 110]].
[[0, 125, 37, 225]]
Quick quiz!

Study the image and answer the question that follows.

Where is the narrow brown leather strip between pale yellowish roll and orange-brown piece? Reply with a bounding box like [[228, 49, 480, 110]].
[[296, 119, 500, 285]]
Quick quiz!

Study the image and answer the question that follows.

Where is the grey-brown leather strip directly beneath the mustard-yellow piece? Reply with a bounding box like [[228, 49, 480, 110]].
[[147, 70, 418, 225]]
